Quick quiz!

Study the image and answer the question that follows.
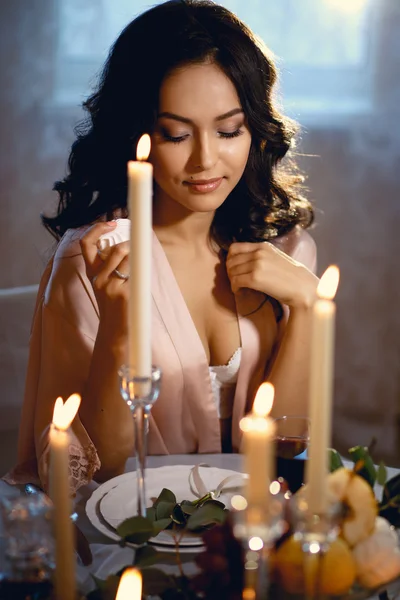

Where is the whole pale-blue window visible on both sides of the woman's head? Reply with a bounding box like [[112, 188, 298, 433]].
[[54, 0, 376, 120]]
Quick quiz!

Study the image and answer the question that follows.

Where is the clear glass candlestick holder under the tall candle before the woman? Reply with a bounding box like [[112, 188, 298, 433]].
[[118, 365, 161, 517]]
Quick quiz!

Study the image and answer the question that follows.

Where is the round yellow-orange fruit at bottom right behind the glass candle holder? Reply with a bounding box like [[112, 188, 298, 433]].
[[273, 536, 356, 596]]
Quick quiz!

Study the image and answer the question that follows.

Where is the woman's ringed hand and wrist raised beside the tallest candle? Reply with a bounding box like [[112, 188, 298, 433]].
[[80, 221, 129, 339]]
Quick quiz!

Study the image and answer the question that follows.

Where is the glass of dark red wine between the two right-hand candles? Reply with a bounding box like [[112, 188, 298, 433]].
[[275, 436, 308, 494]]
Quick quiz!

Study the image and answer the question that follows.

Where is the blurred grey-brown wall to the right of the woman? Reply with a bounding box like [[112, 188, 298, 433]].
[[302, 0, 400, 466]]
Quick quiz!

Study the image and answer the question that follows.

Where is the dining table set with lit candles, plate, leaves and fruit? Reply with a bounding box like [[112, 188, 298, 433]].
[[0, 136, 400, 600]]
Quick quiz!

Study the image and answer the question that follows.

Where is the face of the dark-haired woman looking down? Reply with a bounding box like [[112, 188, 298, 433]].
[[150, 63, 251, 212]]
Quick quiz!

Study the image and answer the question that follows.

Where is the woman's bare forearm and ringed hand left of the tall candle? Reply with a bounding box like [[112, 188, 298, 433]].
[[79, 222, 134, 481]]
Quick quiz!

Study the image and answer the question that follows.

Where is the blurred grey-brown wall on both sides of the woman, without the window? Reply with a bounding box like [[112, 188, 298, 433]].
[[0, 0, 400, 465]]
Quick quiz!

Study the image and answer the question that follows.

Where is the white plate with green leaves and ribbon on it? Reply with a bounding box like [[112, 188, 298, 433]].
[[86, 465, 245, 552]]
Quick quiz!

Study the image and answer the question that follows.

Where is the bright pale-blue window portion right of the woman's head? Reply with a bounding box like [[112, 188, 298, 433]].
[[225, 0, 373, 118]]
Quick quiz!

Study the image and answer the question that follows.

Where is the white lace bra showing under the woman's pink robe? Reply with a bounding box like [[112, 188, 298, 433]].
[[209, 348, 242, 419]]
